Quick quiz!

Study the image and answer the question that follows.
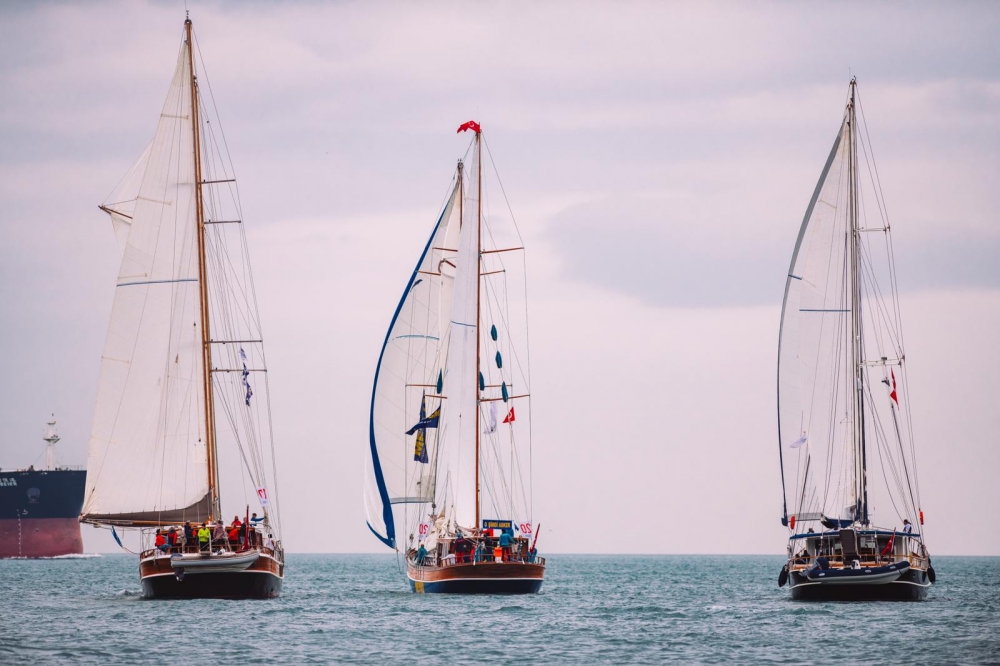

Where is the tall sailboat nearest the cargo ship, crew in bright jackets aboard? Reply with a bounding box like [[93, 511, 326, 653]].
[[80, 18, 284, 598]]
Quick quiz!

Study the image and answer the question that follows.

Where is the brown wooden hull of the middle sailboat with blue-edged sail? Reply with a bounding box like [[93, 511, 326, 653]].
[[406, 562, 545, 594]]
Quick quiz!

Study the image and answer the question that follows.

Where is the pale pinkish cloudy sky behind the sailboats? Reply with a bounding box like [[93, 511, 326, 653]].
[[0, 0, 1000, 555]]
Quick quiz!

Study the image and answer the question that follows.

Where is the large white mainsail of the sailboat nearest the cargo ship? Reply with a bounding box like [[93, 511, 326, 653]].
[[83, 44, 212, 522]]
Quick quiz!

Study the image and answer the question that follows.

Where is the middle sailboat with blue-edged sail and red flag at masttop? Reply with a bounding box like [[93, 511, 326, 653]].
[[365, 121, 545, 594]]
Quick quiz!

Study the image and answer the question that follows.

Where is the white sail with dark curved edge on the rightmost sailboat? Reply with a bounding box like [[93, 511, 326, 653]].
[[778, 117, 853, 522]]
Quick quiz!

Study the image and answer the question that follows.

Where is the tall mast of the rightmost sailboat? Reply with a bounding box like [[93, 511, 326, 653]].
[[848, 78, 868, 526]]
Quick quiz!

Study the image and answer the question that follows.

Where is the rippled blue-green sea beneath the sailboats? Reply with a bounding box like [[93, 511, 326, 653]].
[[0, 554, 1000, 666]]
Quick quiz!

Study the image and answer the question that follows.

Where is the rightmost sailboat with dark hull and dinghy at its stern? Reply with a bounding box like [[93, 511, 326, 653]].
[[778, 79, 936, 600]]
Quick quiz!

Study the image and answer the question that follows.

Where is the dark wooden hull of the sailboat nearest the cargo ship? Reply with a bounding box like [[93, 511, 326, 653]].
[[139, 554, 285, 599]]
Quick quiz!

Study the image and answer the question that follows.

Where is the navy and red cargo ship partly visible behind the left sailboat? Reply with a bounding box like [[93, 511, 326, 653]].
[[0, 419, 87, 558]]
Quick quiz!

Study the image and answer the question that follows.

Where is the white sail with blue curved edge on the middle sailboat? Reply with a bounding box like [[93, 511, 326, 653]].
[[365, 180, 462, 547]]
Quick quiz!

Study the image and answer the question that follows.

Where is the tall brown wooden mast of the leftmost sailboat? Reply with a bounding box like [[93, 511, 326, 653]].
[[184, 18, 219, 520]]
